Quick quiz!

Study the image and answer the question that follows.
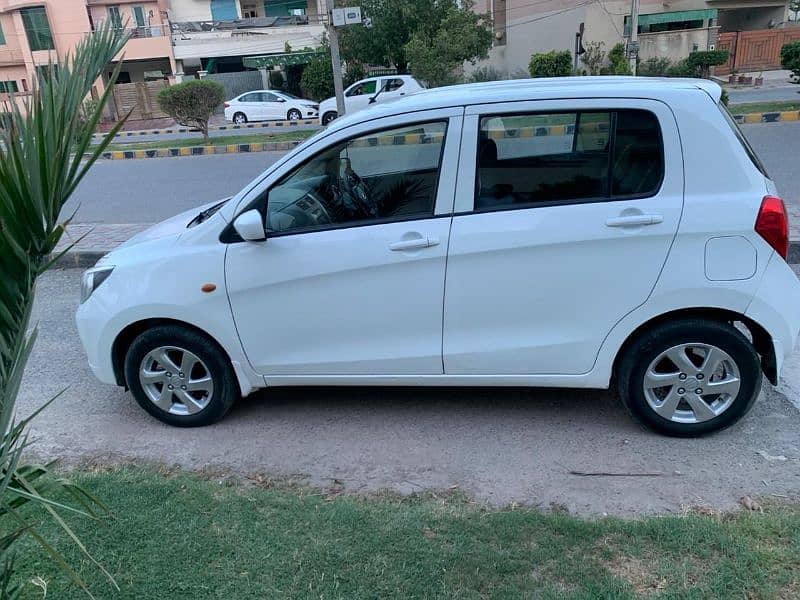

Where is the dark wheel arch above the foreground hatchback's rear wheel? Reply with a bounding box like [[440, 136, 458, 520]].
[[611, 307, 778, 385]]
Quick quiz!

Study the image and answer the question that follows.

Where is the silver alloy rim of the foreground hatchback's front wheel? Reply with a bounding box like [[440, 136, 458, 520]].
[[139, 346, 214, 415]]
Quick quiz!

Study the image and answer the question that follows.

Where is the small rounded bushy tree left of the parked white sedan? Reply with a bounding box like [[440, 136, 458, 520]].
[[158, 79, 225, 143]]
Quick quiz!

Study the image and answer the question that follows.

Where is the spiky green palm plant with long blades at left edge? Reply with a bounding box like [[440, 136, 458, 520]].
[[0, 26, 131, 599]]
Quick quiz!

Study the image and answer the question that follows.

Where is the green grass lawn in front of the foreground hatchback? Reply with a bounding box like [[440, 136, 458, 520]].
[[10, 468, 800, 600]]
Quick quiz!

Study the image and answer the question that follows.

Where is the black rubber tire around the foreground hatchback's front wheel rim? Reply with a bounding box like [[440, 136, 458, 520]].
[[125, 325, 241, 427]]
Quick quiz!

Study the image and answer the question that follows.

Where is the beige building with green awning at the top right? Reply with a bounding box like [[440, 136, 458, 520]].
[[475, 0, 788, 74]]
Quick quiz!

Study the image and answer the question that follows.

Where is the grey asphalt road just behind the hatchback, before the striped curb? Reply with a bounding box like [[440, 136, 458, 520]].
[[69, 123, 800, 223]]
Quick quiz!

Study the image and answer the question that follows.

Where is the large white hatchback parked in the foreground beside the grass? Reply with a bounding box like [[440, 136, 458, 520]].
[[77, 77, 800, 436]]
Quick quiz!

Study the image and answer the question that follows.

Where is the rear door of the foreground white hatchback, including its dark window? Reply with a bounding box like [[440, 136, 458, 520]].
[[443, 100, 683, 374]]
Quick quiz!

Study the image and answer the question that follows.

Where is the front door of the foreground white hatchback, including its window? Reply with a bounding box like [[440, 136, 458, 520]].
[[226, 110, 461, 376]]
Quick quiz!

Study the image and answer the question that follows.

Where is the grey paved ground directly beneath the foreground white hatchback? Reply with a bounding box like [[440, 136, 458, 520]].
[[19, 270, 800, 515]]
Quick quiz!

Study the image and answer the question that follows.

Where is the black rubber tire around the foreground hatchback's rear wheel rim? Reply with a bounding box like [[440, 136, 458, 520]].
[[617, 319, 762, 437]]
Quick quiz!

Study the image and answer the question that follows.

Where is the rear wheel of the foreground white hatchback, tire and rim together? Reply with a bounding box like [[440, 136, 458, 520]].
[[617, 319, 762, 437]]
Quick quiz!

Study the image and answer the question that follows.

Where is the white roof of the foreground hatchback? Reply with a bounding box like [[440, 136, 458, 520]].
[[329, 75, 722, 129]]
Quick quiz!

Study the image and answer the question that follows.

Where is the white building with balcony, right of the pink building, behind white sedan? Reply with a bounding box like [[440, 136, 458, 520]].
[[169, 0, 325, 75]]
